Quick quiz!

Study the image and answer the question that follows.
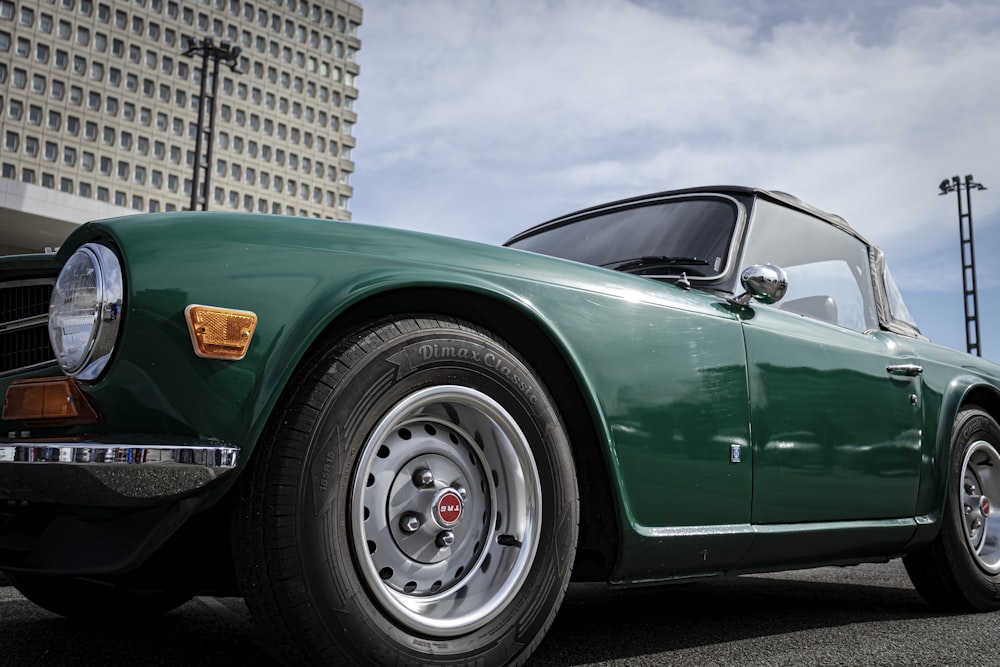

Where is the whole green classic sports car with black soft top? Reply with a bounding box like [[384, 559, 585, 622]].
[[0, 186, 1000, 665]]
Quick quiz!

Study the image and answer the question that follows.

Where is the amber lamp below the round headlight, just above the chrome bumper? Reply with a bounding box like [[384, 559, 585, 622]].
[[3, 378, 101, 426]]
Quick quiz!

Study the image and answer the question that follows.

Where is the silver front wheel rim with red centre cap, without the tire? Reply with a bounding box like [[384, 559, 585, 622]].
[[350, 385, 542, 637]]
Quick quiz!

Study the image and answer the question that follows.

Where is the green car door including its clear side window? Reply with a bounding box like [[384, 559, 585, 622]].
[[742, 201, 921, 524]]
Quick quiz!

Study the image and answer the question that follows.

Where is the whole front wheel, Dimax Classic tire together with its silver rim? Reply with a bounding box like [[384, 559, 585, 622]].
[[234, 316, 579, 666]]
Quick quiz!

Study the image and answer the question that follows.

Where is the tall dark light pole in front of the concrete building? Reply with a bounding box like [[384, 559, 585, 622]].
[[181, 37, 243, 211]]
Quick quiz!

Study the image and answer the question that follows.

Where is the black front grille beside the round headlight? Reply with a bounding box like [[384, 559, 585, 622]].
[[0, 279, 55, 374]]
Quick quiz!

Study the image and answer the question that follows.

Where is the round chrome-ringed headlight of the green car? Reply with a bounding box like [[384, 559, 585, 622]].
[[49, 243, 123, 380]]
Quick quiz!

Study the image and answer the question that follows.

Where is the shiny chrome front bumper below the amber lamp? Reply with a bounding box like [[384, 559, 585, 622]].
[[0, 438, 239, 508]]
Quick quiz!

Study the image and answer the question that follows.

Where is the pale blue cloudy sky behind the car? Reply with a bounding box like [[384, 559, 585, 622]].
[[352, 0, 1000, 361]]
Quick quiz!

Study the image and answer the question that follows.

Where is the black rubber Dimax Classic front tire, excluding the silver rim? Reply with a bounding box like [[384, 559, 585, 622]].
[[235, 316, 579, 665]]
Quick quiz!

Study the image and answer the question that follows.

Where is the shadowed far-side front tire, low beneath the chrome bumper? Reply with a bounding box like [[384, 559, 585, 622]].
[[6, 572, 192, 621]]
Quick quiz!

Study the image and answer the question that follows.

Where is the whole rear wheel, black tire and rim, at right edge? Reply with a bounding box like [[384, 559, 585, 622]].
[[903, 406, 1000, 611]]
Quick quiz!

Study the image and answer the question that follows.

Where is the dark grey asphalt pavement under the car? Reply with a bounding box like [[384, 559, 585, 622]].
[[0, 561, 1000, 667]]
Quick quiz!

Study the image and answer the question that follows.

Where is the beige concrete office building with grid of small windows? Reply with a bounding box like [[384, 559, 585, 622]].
[[0, 0, 362, 253]]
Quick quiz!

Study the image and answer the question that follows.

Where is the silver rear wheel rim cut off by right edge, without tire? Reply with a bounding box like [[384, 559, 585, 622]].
[[959, 440, 1000, 574]]
